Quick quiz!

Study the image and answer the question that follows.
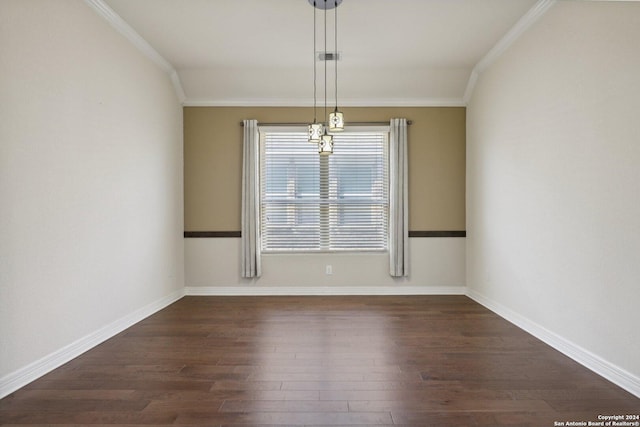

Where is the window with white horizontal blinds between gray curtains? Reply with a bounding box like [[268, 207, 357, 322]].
[[260, 128, 389, 252]]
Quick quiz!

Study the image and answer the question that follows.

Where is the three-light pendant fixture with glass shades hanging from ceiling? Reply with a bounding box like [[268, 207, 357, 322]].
[[308, 0, 344, 155]]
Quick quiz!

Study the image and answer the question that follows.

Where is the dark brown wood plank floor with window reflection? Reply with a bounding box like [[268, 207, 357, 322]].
[[0, 296, 640, 427]]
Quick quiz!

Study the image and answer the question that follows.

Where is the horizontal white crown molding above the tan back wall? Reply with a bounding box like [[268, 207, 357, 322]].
[[182, 98, 466, 107]]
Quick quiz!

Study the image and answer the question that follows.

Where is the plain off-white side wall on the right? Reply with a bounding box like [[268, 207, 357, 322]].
[[466, 1, 640, 393]]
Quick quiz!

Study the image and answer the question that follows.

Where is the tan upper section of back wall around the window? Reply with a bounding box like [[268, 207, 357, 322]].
[[184, 107, 466, 231]]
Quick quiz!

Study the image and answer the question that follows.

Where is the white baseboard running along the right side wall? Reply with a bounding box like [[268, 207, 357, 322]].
[[467, 289, 640, 397]]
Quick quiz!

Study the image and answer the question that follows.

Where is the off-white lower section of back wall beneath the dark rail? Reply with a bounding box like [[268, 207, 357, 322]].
[[185, 237, 465, 294]]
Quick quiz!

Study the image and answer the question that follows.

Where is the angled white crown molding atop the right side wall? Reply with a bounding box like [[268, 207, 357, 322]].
[[463, 0, 557, 105]]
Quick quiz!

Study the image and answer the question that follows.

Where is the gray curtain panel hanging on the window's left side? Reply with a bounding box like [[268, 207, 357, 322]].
[[241, 120, 261, 278]]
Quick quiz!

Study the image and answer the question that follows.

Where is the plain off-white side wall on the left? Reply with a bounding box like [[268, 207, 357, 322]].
[[0, 0, 184, 387]]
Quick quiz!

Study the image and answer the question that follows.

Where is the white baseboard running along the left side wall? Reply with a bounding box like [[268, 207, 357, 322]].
[[0, 289, 184, 399]]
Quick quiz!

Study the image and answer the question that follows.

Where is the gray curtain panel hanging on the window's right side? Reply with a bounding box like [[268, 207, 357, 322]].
[[389, 119, 409, 277]]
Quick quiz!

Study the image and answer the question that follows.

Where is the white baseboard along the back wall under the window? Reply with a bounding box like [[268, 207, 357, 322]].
[[185, 286, 467, 296]]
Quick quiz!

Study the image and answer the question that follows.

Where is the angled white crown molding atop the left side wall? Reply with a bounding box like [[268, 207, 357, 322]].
[[84, 0, 186, 103]]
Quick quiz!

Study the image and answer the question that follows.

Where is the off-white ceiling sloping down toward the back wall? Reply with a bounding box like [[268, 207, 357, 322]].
[[102, 0, 536, 106]]
